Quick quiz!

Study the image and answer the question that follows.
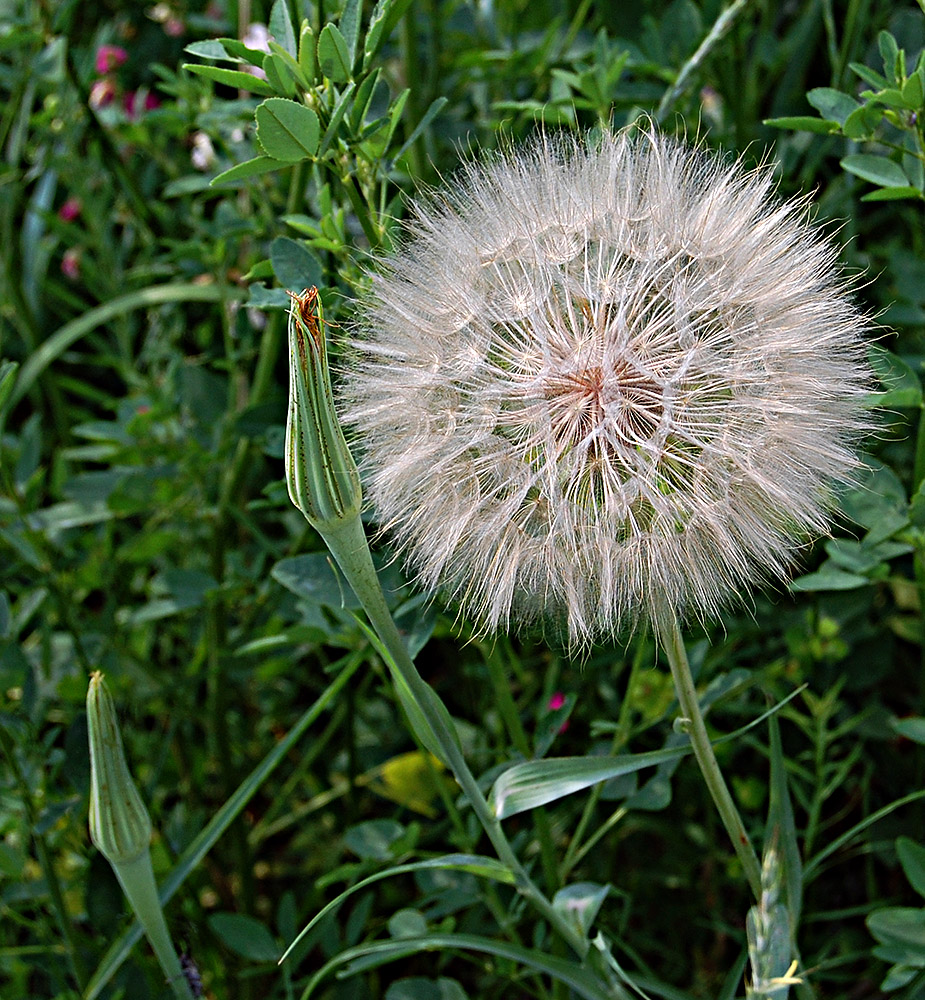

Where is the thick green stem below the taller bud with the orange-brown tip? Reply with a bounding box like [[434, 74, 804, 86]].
[[322, 517, 589, 958]]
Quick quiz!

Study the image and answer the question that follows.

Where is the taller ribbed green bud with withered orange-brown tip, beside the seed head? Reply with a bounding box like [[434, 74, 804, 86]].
[[286, 288, 362, 532]]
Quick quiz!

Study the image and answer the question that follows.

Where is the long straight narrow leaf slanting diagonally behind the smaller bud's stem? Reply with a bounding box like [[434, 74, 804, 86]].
[[83, 653, 363, 1000]]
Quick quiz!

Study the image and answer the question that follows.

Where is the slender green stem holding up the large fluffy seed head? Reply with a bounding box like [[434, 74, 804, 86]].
[[658, 615, 761, 900]]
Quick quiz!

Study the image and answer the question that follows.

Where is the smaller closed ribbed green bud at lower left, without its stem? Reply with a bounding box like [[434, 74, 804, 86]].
[[87, 670, 151, 866]]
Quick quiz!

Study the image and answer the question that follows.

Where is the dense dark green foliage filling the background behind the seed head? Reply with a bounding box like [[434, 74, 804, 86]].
[[0, 0, 925, 1000]]
